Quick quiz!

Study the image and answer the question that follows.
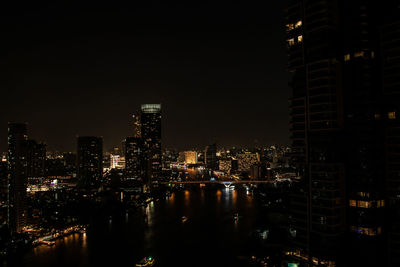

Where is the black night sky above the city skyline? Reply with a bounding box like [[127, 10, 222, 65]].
[[0, 0, 290, 151]]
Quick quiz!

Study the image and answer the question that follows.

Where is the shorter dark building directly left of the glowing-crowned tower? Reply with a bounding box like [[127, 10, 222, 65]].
[[125, 137, 143, 180]]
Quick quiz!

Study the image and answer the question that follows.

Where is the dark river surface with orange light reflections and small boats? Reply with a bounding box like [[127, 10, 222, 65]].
[[8, 187, 263, 267]]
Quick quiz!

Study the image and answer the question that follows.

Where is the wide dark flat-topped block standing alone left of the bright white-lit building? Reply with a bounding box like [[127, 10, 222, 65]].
[[77, 136, 103, 188]]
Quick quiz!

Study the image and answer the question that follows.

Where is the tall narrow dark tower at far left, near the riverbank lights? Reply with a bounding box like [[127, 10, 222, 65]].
[[7, 123, 28, 232]]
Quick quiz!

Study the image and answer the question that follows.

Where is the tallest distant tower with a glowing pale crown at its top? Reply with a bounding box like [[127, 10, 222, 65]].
[[140, 104, 162, 186]]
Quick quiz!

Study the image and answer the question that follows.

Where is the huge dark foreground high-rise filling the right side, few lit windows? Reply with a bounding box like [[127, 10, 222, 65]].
[[286, 0, 400, 266]]
